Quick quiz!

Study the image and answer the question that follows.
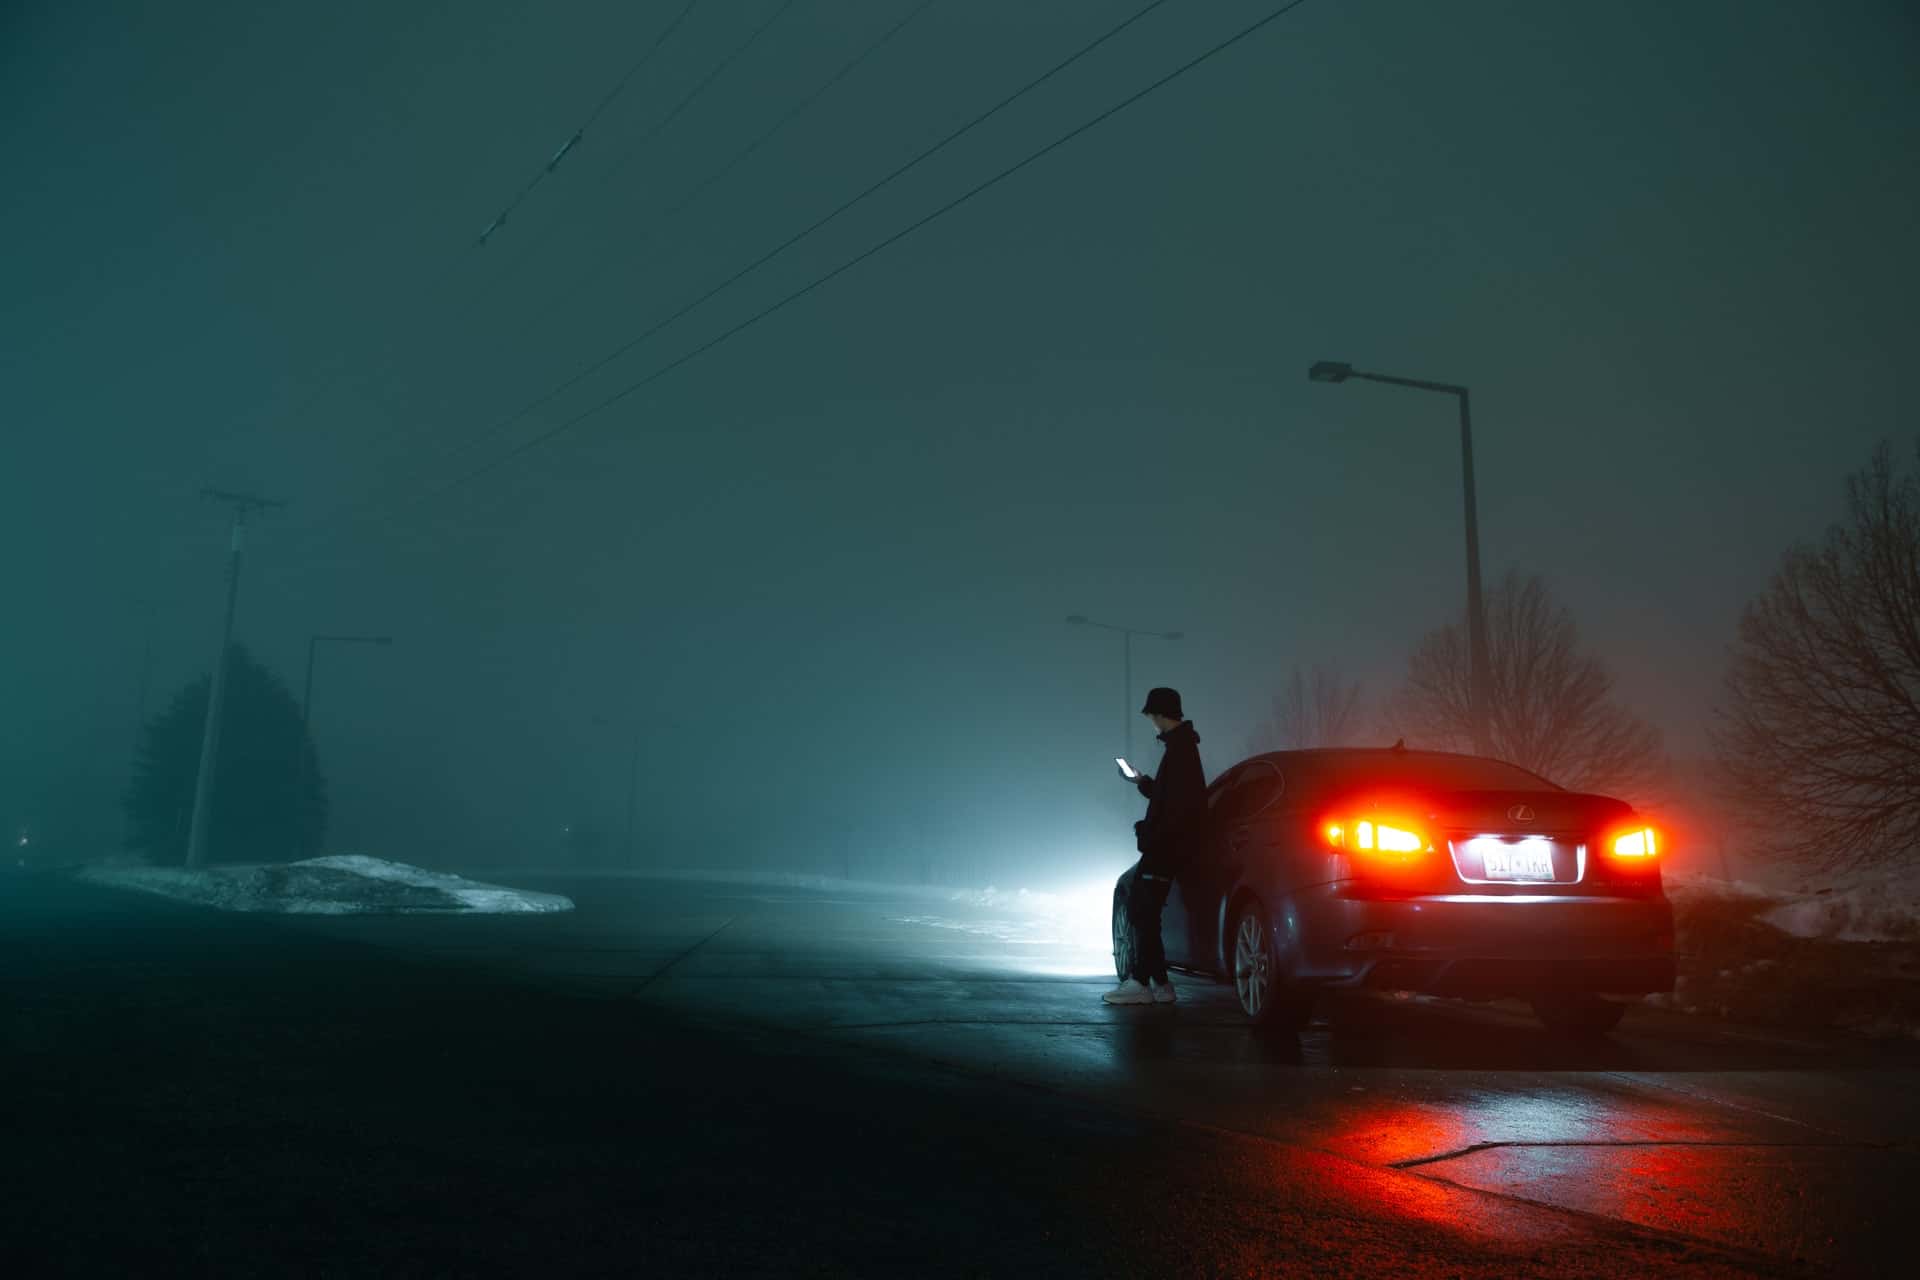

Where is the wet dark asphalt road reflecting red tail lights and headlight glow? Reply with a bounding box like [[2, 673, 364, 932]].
[[0, 875, 1920, 1276]]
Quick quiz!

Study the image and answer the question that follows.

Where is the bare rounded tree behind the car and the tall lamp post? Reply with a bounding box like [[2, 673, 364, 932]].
[[1384, 570, 1667, 802]]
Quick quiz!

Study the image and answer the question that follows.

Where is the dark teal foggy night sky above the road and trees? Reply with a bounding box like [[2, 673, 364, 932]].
[[0, 0, 1920, 883]]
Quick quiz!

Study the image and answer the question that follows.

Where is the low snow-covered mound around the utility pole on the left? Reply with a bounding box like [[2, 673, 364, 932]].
[[81, 854, 574, 915]]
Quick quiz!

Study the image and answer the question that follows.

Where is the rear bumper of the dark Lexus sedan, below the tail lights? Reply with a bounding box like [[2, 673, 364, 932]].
[[1275, 881, 1674, 998]]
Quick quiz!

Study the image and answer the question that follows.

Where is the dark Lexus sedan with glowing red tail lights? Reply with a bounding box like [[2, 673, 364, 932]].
[[1114, 747, 1674, 1034]]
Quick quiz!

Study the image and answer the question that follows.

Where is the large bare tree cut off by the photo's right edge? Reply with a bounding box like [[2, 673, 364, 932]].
[[1715, 445, 1920, 867]]
